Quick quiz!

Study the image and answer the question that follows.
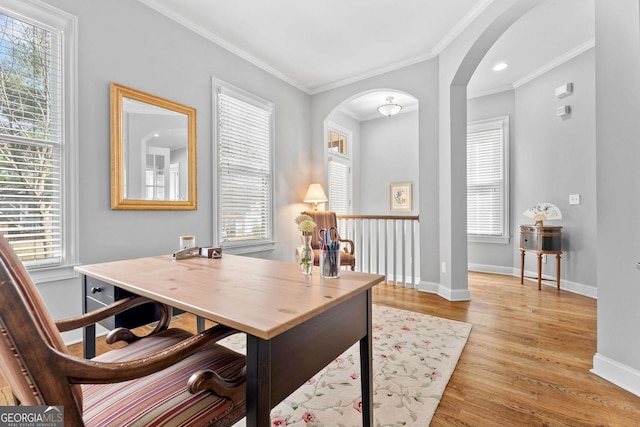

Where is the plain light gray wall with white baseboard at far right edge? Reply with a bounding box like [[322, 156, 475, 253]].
[[593, 0, 640, 396]]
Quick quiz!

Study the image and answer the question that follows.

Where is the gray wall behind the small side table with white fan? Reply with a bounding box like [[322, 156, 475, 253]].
[[511, 49, 597, 296]]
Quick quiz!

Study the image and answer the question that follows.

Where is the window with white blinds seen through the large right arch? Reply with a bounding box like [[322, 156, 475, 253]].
[[467, 116, 509, 242]]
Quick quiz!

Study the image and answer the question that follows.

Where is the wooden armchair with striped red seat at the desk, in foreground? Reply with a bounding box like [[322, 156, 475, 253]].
[[0, 236, 246, 427]]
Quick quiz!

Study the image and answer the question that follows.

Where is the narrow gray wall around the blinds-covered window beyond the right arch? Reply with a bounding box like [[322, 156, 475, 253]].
[[467, 90, 518, 274]]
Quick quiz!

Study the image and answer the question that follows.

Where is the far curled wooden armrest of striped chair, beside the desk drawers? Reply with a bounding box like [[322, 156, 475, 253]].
[[55, 296, 171, 333]]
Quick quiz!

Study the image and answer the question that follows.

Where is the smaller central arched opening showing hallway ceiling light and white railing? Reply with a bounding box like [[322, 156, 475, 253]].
[[322, 88, 420, 286]]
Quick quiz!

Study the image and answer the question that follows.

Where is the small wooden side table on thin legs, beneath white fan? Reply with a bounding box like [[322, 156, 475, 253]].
[[520, 225, 562, 290]]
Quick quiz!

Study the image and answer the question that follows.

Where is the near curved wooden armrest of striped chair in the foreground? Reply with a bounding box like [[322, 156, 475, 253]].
[[54, 325, 239, 384]]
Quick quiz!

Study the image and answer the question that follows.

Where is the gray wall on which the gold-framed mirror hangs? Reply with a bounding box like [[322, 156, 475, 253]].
[[39, 0, 310, 341]]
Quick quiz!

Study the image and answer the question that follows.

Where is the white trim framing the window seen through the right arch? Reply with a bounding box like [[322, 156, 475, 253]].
[[467, 116, 511, 244]]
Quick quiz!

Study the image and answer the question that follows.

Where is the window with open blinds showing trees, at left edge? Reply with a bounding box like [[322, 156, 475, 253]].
[[0, 0, 76, 270]]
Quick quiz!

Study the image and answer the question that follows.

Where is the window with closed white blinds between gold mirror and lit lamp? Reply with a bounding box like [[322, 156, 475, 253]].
[[214, 80, 273, 252]]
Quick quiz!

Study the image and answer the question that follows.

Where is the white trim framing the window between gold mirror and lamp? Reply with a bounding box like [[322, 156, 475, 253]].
[[212, 77, 276, 255]]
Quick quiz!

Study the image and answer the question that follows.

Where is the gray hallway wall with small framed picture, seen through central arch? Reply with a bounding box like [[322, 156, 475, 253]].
[[358, 111, 420, 215]]
